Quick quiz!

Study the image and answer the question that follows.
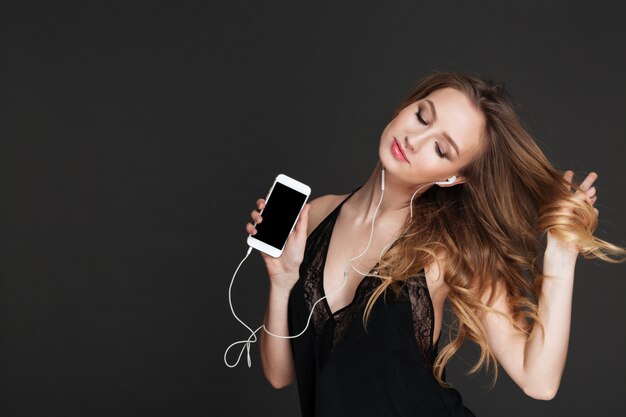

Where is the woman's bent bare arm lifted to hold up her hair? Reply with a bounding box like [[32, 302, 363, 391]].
[[476, 173, 597, 400]]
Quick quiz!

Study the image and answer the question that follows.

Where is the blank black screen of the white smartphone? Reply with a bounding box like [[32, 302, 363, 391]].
[[253, 182, 307, 249]]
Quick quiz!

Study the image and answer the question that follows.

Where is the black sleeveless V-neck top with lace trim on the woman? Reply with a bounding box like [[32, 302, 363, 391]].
[[288, 186, 474, 417]]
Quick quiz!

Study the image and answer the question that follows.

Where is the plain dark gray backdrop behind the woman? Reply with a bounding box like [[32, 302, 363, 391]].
[[0, 1, 626, 417]]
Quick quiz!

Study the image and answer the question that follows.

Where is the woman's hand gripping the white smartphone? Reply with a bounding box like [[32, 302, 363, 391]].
[[246, 198, 311, 290]]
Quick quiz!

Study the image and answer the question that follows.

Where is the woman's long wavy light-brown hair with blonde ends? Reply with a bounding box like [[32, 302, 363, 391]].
[[363, 72, 626, 387]]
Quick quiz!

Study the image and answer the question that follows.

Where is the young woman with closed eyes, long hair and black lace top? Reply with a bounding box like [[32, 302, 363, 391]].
[[246, 72, 626, 417]]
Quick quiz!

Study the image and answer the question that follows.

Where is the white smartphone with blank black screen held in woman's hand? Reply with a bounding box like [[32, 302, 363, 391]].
[[247, 174, 311, 258]]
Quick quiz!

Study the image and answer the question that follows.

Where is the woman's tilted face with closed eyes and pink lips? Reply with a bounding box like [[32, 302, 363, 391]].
[[379, 87, 485, 184]]
